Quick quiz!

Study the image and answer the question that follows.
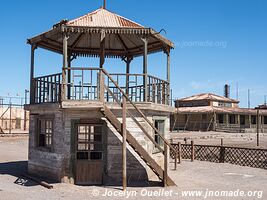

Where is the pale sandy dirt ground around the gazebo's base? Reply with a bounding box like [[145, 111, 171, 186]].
[[0, 134, 267, 200]]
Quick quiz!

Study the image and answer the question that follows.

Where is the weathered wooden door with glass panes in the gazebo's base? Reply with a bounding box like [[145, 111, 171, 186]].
[[75, 124, 103, 185]]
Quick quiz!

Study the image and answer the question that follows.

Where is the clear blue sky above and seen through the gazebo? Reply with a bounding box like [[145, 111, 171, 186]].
[[0, 0, 267, 107]]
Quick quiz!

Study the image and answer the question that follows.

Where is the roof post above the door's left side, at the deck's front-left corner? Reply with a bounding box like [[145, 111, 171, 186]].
[[61, 33, 68, 101]]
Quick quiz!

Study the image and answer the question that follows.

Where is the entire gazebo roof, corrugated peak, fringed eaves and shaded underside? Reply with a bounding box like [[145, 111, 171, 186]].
[[28, 8, 174, 57]]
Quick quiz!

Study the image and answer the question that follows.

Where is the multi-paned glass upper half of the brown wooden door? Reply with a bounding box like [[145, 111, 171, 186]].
[[77, 124, 103, 160]]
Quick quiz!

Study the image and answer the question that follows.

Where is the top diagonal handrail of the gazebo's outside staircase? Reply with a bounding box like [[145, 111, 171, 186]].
[[102, 69, 175, 150]]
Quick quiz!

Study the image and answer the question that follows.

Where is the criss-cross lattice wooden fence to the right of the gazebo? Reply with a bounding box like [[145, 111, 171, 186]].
[[170, 144, 267, 169]]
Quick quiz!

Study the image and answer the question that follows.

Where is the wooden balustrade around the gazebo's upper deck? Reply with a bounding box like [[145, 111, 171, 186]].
[[34, 67, 170, 105]]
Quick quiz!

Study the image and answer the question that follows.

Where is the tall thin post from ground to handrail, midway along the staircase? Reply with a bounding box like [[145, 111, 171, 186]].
[[122, 96, 127, 191]]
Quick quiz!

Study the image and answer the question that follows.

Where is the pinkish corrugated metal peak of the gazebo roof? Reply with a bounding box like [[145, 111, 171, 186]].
[[67, 8, 144, 28]]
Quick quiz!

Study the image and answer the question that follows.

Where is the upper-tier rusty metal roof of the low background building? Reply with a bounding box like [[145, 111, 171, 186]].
[[178, 93, 239, 103]]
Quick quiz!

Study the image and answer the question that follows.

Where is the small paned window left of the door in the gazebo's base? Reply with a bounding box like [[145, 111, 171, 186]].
[[38, 119, 53, 148]]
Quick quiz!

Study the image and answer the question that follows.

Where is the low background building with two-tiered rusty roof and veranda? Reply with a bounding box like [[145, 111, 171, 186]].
[[171, 93, 267, 132]]
